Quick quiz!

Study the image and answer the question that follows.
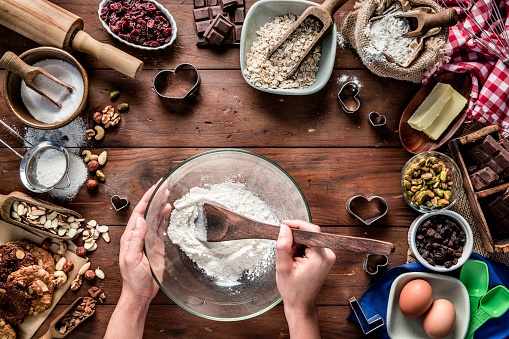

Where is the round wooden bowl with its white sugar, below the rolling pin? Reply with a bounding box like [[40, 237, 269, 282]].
[[4, 47, 89, 129]]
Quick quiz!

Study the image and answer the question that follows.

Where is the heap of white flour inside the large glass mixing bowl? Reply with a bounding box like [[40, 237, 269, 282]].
[[168, 182, 279, 285]]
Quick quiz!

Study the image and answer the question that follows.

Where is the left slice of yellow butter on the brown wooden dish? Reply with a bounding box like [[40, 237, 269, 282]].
[[407, 82, 454, 131]]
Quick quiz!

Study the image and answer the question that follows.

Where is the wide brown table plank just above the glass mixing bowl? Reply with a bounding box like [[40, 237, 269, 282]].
[[0, 70, 418, 147]]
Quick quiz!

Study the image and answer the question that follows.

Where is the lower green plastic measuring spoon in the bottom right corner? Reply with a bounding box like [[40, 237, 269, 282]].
[[465, 285, 509, 339]]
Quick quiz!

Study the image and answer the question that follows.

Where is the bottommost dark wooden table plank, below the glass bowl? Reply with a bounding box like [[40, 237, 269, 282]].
[[34, 305, 376, 339]]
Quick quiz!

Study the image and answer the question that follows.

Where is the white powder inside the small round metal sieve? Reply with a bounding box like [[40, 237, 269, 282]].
[[36, 148, 67, 188]]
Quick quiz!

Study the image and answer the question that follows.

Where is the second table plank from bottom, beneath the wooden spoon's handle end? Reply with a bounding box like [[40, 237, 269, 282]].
[[51, 226, 408, 305]]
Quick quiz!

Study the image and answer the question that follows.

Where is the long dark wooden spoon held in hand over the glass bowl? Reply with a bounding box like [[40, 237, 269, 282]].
[[195, 203, 394, 255]]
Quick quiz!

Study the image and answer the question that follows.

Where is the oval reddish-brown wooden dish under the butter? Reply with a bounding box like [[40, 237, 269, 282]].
[[399, 73, 472, 154]]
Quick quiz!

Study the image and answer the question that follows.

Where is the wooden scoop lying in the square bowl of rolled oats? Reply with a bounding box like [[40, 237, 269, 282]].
[[266, 0, 348, 78]]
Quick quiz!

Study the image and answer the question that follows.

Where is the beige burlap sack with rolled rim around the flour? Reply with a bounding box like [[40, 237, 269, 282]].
[[341, 0, 449, 83]]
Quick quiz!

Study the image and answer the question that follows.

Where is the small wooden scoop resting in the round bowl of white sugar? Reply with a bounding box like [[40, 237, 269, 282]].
[[0, 52, 72, 108]]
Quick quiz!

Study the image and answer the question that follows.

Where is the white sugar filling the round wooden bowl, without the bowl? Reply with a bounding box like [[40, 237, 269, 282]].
[[21, 59, 84, 124]]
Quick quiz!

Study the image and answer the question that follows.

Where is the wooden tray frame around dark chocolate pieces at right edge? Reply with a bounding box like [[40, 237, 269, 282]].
[[448, 125, 509, 253]]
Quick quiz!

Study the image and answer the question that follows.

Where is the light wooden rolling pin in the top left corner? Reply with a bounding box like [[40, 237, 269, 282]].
[[0, 0, 143, 78]]
